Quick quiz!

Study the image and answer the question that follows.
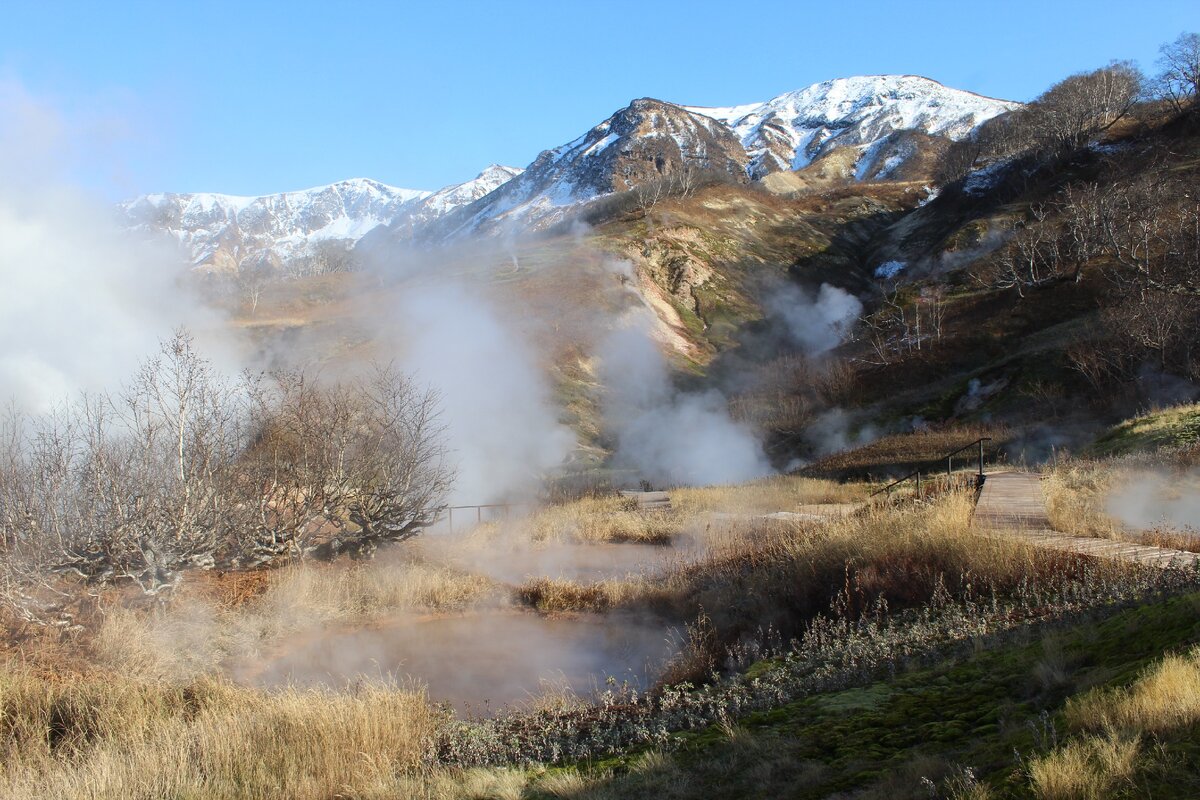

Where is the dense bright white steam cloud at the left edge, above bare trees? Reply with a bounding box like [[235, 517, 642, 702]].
[[0, 83, 231, 413]]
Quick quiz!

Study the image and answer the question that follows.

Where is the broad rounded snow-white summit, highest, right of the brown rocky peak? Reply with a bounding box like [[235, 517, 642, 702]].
[[688, 76, 1020, 180]]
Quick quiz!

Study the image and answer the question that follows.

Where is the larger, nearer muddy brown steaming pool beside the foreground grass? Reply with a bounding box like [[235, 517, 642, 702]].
[[234, 609, 678, 716]]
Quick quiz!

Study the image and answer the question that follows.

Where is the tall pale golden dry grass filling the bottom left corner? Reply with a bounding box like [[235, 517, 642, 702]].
[[0, 666, 438, 800]]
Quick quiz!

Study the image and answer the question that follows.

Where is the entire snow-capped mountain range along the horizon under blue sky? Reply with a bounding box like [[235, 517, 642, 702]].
[[121, 76, 1019, 263]]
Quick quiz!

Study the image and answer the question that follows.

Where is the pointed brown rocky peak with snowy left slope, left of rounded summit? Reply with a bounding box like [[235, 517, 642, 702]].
[[417, 98, 746, 237]]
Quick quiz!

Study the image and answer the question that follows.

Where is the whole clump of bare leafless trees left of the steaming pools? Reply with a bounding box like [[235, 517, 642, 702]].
[[0, 331, 454, 614]]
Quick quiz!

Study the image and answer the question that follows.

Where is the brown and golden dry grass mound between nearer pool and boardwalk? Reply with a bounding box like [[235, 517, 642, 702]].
[[520, 492, 1099, 680]]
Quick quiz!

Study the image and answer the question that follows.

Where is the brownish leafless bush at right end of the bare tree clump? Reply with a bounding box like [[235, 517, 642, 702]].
[[239, 367, 454, 566]]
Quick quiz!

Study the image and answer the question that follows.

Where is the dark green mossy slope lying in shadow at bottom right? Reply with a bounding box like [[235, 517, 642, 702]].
[[530, 594, 1200, 800]]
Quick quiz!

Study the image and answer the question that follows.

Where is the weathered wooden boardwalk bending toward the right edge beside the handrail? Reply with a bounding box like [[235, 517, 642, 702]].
[[972, 473, 1200, 567]]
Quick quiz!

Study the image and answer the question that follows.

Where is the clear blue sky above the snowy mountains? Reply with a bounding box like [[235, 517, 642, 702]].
[[0, 0, 1200, 197]]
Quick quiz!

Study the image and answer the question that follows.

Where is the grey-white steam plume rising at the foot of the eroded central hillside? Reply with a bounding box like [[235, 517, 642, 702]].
[[600, 312, 772, 486]]
